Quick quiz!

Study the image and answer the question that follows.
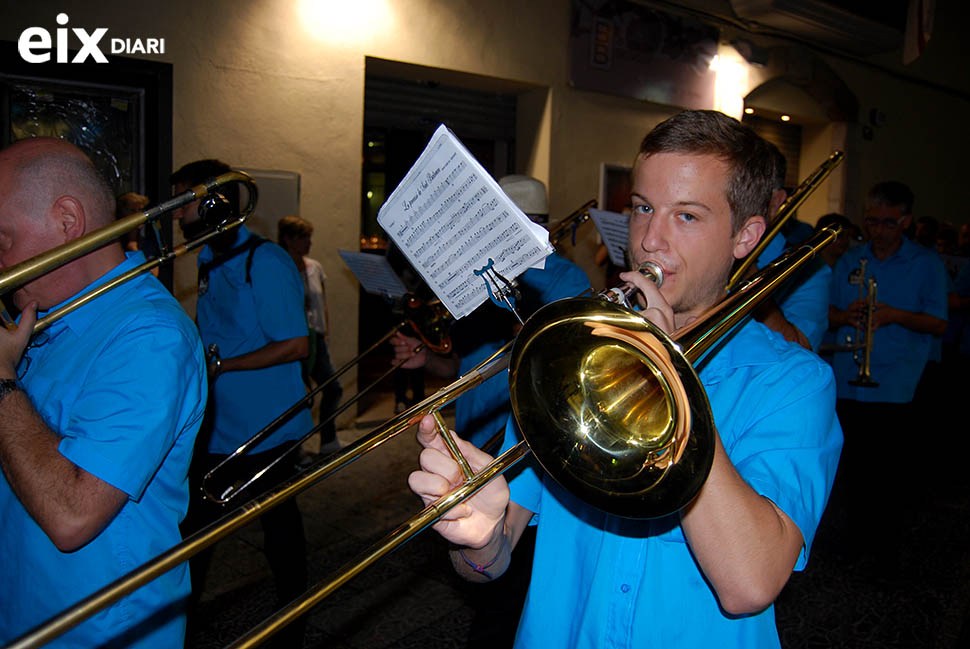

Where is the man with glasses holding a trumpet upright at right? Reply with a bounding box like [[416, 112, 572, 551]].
[[829, 181, 947, 562]]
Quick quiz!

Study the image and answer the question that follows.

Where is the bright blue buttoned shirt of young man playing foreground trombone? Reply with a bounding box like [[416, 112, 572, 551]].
[[506, 322, 842, 648]]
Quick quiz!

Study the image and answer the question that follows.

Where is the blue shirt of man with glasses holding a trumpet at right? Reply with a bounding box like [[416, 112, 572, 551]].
[[830, 238, 947, 403]]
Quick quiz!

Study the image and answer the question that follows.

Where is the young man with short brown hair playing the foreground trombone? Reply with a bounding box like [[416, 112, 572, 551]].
[[410, 111, 842, 647]]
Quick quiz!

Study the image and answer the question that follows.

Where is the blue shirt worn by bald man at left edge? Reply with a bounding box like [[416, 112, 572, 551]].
[[0, 252, 206, 649]]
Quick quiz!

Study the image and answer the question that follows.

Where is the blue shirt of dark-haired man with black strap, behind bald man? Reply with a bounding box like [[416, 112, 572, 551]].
[[196, 226, 313, 454]]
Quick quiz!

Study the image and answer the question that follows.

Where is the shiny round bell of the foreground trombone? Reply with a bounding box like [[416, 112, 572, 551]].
[[509, 298, 714, 518]]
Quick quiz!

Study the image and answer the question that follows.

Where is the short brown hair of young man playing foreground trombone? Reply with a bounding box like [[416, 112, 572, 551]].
[[638, 110, 776, 232]]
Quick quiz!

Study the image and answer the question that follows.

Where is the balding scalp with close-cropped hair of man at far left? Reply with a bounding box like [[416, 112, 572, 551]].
[[0, 138, 115, 231]]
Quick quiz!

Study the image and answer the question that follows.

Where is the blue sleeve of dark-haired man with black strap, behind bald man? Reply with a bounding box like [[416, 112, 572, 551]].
[[251, 243, 309, 342]]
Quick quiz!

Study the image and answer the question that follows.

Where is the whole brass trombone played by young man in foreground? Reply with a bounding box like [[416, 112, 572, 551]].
[[8, 226, 839, 649]]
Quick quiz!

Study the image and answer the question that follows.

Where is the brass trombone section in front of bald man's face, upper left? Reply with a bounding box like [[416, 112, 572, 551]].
[[0, 171, 259, 335]]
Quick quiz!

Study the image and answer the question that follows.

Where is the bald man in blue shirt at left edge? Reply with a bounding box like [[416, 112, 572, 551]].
[[0, 138, 206, 648]]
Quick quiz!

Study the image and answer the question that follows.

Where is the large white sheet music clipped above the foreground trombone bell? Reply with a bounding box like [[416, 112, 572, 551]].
[[377, 124, 552, 318]]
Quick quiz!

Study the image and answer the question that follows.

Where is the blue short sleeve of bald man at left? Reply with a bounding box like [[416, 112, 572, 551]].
[[58, 306, 206, 501]]
